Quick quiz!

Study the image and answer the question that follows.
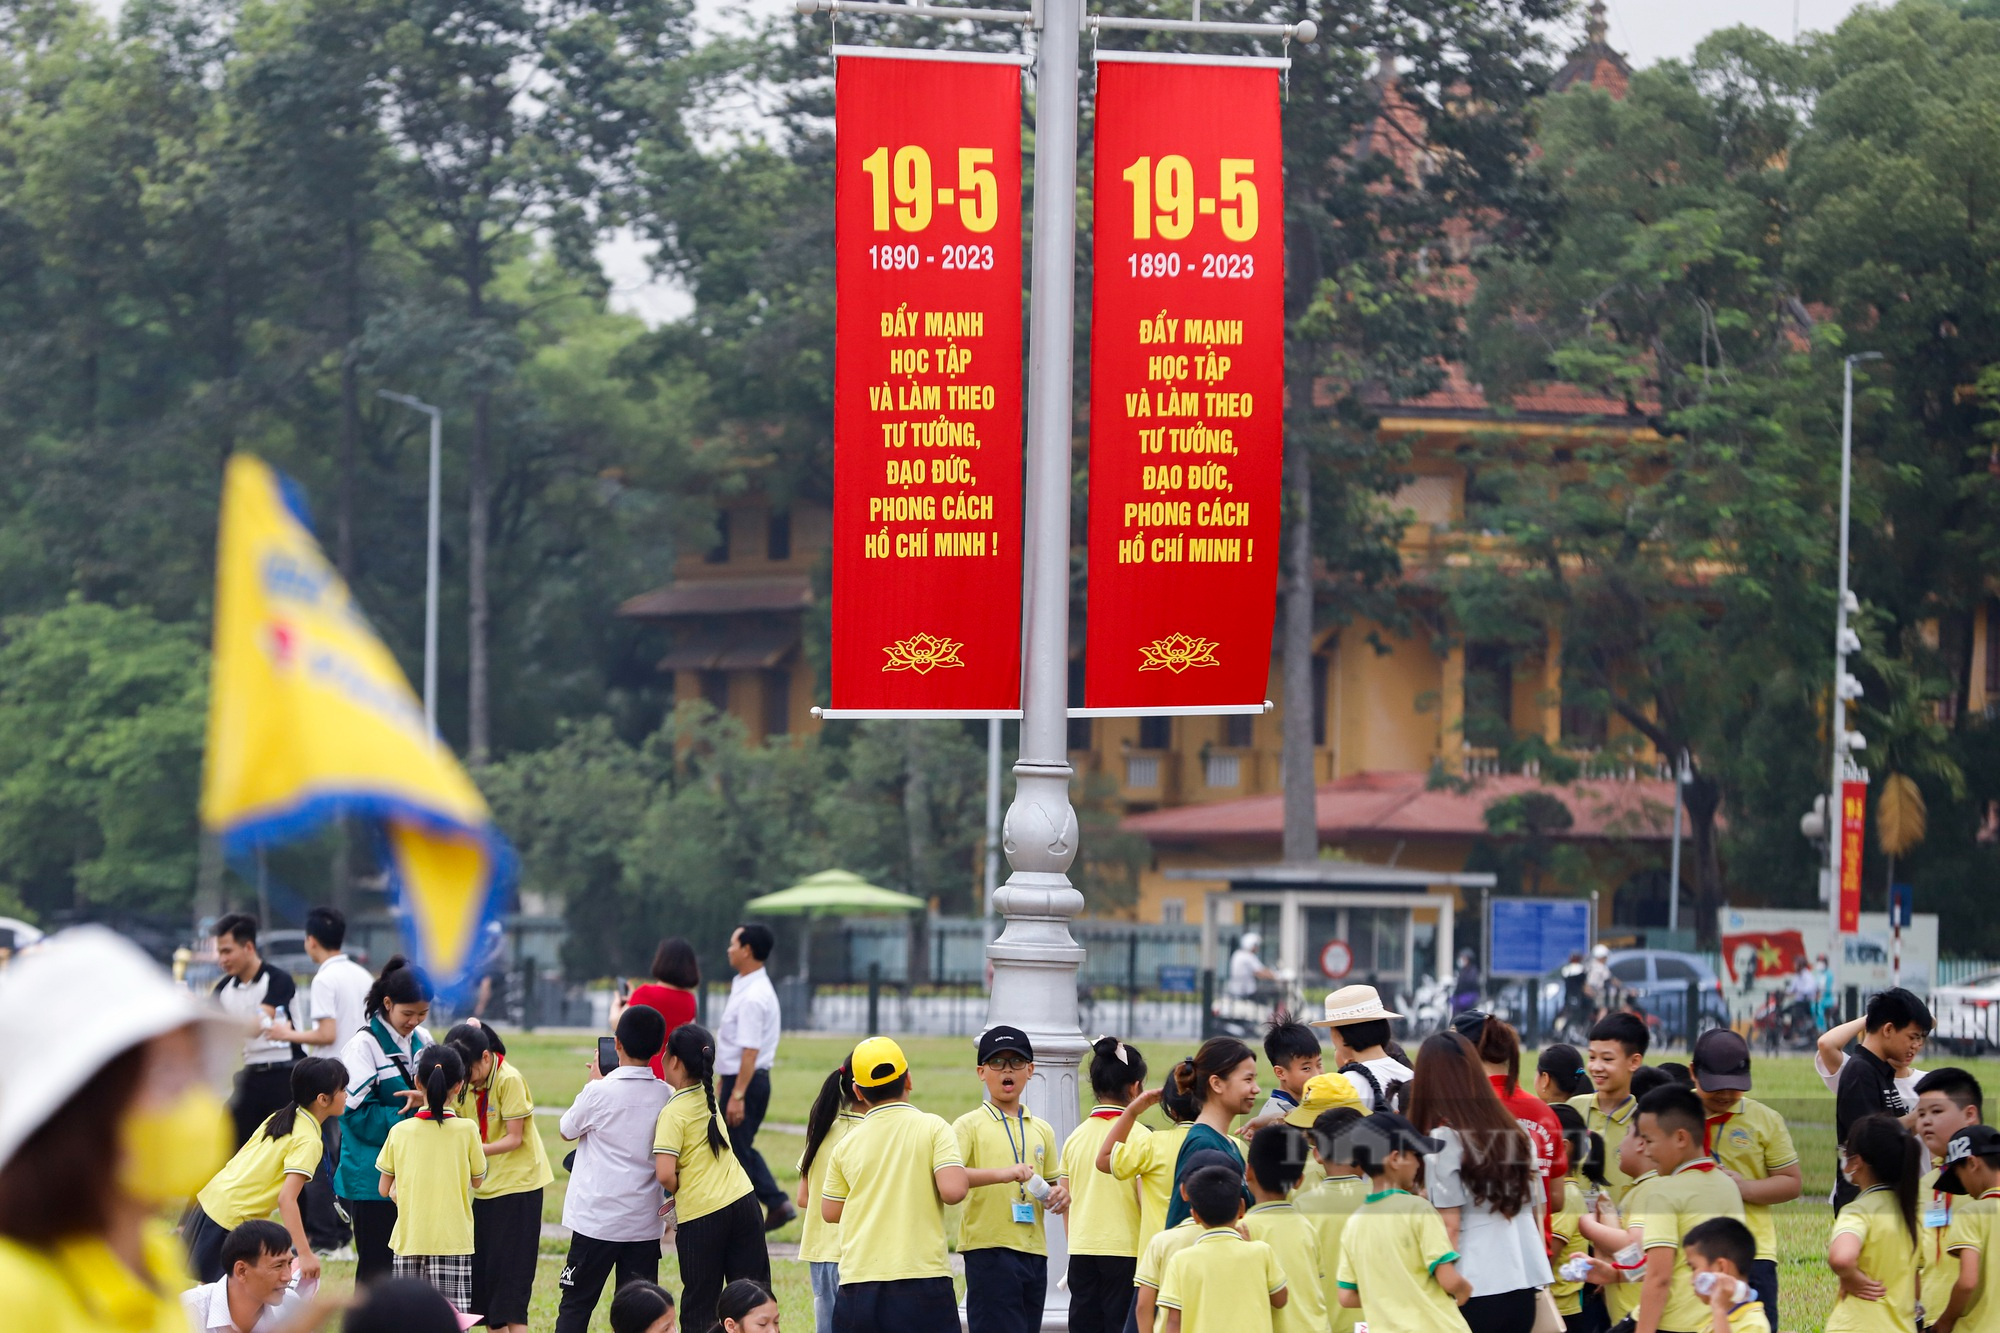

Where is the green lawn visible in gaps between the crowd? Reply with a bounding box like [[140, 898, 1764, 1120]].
[[300, 1033, 2000, 1333]]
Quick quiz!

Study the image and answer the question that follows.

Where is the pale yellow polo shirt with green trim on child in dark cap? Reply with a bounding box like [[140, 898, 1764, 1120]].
[[1334, 1189, 1466, 1333]]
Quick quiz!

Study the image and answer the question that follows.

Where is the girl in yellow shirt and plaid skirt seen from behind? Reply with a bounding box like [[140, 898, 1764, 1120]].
[[376, 1045, 486, 1313]]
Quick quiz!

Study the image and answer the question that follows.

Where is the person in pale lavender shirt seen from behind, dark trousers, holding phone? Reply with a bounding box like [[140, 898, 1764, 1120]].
[[556, 1005, 674, 1333]]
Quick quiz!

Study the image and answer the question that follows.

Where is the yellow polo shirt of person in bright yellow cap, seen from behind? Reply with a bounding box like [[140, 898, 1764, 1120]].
[[820, 1101, 966, 1285]]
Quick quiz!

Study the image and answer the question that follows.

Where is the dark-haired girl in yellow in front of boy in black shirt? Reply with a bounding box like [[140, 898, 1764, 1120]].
[[1826, 1115, 1924, 1333]]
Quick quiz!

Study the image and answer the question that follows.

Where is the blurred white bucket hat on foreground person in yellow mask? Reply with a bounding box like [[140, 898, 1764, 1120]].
[[0, 927, 246, 1167]]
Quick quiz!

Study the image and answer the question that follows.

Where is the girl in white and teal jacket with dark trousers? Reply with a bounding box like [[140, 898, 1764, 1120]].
[[334, 955, 432, 1285]]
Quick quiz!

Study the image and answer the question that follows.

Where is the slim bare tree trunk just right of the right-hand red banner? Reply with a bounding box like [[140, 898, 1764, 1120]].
[[1282, 356, 1320, 865]]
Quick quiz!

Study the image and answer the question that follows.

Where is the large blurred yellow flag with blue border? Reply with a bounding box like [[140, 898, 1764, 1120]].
[[202, 454, 512, 991]]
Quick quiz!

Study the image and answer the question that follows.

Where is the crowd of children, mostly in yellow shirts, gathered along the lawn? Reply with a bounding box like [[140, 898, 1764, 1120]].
[[164, 948, 2000, 1333]]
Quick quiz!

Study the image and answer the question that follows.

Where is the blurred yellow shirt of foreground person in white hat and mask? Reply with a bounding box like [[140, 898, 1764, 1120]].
[[0, 1216, 189, 1333]]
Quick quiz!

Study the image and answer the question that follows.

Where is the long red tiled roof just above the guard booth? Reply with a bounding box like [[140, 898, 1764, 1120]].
[[1120, 773, 1674, 843]]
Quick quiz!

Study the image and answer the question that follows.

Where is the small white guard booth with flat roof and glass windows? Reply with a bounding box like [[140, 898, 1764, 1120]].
[[1166, 861, 1494, 1017]]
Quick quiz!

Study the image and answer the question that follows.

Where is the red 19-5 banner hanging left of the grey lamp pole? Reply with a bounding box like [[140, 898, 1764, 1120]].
[[832, 56, 1022, 713]]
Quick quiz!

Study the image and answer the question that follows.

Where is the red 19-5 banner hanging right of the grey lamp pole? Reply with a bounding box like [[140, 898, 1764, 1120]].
[[1084, 60, 1284, 709]]
